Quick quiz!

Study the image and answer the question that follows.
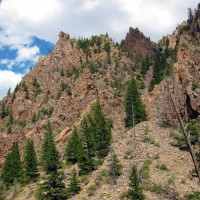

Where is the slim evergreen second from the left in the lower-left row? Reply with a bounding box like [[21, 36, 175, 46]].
[[24, 139, 38, 181]]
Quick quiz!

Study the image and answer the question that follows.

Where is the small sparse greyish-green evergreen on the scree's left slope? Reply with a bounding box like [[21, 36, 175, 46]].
[[108, 154, 122, 184]]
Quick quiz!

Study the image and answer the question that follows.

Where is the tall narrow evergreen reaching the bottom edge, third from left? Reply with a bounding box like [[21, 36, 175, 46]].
[[37, 121, 67, 200]]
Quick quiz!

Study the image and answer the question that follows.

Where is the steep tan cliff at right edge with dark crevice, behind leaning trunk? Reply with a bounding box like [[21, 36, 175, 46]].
[[146, 12, 200, 125]]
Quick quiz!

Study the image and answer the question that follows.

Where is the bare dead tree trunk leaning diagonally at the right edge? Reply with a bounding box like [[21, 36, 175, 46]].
[[166, 78, 200, 182]]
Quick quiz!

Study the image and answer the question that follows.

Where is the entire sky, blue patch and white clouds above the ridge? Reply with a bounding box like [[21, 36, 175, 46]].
[[0, 0, 199, 99]]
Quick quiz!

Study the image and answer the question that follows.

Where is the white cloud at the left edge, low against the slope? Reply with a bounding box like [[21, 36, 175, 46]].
[[0, 70, 23, 100]]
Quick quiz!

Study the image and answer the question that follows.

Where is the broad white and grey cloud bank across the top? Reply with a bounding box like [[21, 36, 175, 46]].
[[0, 0, 199, 42]]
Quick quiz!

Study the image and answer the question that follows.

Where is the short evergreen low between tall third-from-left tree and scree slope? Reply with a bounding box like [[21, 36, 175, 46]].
[[68, 169, 81, 196]]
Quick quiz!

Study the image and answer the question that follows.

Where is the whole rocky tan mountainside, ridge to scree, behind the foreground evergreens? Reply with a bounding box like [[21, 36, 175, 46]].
[[0, 3, 200, 200]]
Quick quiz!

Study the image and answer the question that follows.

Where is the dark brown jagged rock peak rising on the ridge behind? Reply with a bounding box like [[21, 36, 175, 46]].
[[121, 27, 156, 57]]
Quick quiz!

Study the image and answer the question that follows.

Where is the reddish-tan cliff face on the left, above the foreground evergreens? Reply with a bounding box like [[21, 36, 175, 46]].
[[0, 32, 133, 164]]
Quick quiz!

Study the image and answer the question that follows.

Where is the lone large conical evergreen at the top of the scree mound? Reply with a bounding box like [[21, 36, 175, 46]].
[[125, 78, 147, 127]]
